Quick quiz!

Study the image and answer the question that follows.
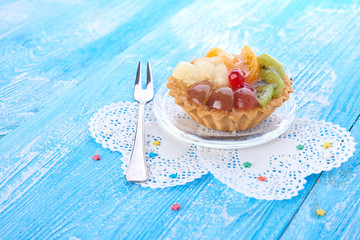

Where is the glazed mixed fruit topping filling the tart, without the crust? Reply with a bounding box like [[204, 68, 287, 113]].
[[177, 46, 285, 111]]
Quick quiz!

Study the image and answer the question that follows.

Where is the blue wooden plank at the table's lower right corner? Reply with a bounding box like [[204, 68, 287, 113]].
[[282, 121, 360, 239]]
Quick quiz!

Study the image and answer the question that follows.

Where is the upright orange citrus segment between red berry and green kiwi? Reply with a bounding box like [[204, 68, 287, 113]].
[[236, 45, 260, 84]]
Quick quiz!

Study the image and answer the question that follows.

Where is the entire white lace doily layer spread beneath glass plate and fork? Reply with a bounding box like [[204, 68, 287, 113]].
[[89, 102, 356, 200]]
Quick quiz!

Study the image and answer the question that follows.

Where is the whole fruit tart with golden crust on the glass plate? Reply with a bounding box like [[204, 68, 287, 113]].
[[166, 46, 294, 131]]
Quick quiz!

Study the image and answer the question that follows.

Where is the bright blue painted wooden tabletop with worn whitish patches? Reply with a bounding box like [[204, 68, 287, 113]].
[[0, 0, 360, 239]]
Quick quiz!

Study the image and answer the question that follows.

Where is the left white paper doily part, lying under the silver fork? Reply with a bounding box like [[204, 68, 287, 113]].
[[89, 102, 208, 188]]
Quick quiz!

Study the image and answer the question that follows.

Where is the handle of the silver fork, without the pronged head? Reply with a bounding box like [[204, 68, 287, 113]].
[[125, 103, 149, 182]]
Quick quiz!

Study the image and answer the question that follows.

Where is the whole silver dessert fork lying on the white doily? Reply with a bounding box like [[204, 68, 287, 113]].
[[125, 62, 154, 182]]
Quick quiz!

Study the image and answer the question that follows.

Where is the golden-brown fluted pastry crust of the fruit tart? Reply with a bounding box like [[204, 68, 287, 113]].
[[166, 71, 294, 131]]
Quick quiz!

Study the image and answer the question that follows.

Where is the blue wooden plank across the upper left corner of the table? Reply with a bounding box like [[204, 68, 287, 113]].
[[0, 1, 194, 138]]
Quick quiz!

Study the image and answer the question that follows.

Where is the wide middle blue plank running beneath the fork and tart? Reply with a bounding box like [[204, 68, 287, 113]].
[[0, 1, 360, 239]]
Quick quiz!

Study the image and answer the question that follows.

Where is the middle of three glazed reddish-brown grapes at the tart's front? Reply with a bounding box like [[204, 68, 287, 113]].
[[206, 87, 234, 111]]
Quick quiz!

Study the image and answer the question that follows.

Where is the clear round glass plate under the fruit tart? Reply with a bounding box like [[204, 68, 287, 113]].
[[154, 85, 296, 148]]
